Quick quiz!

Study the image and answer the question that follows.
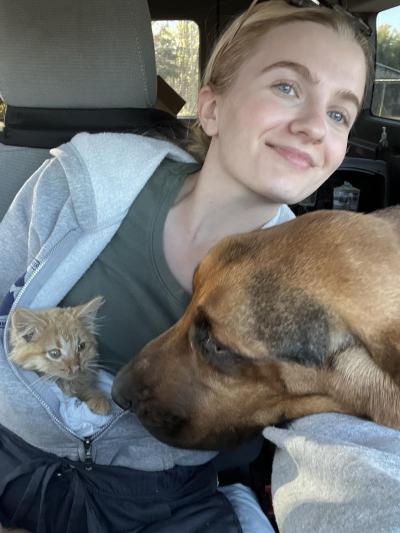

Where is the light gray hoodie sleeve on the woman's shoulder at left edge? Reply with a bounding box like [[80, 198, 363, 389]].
[[0, 159, 69, 302]]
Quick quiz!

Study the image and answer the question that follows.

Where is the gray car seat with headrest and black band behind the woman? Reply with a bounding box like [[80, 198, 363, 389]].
[[0, 0, 159, 220]]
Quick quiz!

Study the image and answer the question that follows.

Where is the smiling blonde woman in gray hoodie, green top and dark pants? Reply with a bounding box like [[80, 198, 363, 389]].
[[0, 1, 369, 533]]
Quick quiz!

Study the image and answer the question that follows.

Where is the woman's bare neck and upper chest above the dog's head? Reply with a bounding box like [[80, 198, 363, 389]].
[[164, 160, 279, 291]]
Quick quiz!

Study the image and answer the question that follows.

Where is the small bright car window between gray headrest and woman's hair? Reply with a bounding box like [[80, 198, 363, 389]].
[[152, 20, 199, 117]]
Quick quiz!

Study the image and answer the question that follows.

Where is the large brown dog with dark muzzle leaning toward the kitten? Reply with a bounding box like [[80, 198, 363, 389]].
[[113, 207, 400, 449]]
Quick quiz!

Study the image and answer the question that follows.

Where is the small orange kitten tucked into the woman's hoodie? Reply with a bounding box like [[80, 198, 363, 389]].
[[10, 296, 111, 415]]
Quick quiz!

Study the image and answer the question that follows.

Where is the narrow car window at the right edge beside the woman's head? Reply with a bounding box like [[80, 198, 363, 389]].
[[372, 6, 400, 120]]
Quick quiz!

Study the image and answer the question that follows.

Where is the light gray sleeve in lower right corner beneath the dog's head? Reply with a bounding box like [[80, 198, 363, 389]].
[[263, 413, 400, 533]]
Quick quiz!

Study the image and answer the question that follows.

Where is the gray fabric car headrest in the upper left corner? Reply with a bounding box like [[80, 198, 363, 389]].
[[0, 0, 157, 109]]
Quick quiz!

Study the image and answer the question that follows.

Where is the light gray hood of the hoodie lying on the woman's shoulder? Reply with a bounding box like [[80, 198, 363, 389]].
[[51, 133, 194, 231]]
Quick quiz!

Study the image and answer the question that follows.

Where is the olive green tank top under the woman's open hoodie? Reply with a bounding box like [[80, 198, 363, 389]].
[[60, 159, 199, 373]]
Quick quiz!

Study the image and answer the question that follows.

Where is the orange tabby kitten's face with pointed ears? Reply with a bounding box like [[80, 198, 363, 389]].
[[10, 298, 103, 380]]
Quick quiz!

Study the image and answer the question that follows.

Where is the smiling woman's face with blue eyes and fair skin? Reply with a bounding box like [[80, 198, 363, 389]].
[[206, 22, 366, 204]]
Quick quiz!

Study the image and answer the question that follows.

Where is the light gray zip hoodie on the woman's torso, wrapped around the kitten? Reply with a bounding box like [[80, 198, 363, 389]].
[[0, 133, 294, 470]]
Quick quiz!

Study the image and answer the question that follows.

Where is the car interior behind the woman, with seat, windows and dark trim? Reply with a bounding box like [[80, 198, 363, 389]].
[[0, 0, 400, 524]]
